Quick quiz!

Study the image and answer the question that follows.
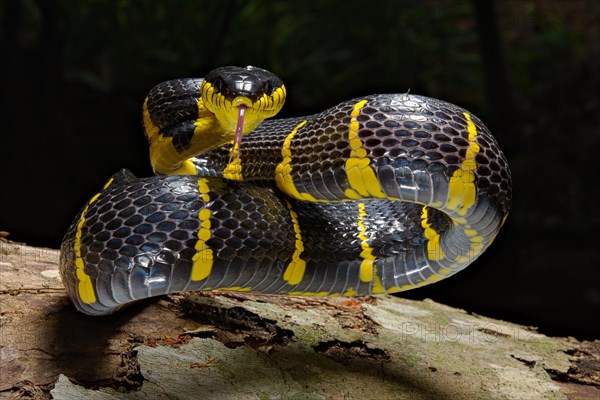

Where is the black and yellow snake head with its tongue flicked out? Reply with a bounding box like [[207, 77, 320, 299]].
[[200, 66, 286, 138]]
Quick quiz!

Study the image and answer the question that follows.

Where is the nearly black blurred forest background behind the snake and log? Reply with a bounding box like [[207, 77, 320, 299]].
[[0, 0, 600, 339]]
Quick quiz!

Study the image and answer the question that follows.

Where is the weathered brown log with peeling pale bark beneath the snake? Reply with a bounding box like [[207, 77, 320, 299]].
[[0, 240, 600, 400]]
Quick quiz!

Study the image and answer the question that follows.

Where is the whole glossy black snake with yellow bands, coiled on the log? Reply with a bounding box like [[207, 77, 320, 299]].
[[60, 67, 511, 315]]
